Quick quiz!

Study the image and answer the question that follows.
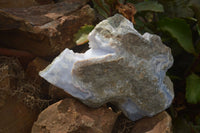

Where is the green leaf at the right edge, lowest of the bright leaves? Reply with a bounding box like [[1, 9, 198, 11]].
[[186, 74, 200, 104]]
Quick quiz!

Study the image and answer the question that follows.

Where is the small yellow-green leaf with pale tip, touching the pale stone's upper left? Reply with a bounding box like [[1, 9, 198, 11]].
[[74, 25, 94, 45]]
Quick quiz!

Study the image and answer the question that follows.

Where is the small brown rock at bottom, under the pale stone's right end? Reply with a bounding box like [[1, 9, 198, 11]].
[[131, 111, 172, 133]]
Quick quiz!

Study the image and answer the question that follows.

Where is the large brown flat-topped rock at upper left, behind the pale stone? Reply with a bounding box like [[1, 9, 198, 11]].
[[0, 0, 95, 56]]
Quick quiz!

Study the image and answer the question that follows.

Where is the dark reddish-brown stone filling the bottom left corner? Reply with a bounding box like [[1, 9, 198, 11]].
[[0, 97, 38, 133]]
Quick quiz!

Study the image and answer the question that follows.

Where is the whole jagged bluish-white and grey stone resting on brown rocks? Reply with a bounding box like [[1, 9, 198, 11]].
[[40, 14, 174, 120]]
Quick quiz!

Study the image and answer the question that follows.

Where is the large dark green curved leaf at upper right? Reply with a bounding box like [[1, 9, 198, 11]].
[[158, 18, 196, 54]]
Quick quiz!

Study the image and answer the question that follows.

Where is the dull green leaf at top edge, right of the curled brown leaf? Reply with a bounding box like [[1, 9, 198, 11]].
[[135, 1, 164, 12]]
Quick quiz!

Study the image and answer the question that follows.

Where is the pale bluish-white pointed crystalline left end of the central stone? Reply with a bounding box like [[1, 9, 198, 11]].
[[39, 49, 114, 99]]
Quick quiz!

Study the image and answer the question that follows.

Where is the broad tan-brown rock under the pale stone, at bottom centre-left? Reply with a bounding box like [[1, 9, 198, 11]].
[[32, 98, 118, 133]]
